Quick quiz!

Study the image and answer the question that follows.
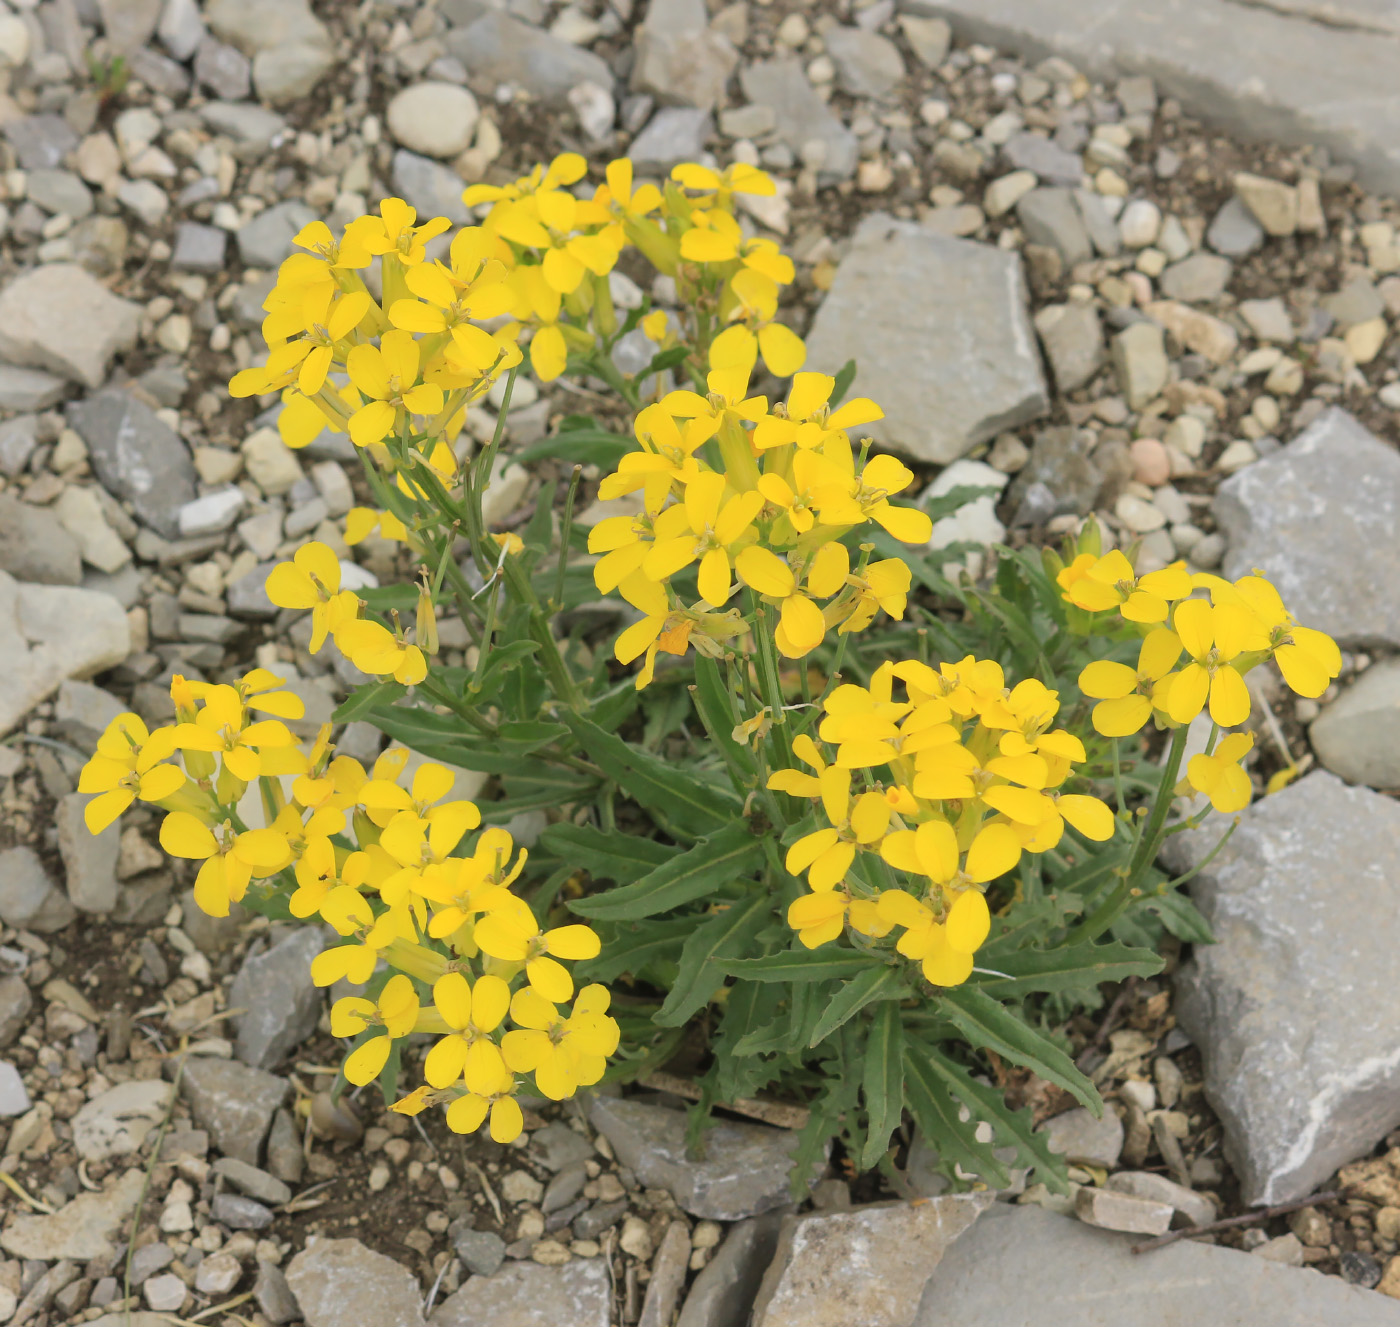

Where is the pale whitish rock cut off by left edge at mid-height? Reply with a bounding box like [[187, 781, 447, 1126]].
[[0, 571, 132, 733]]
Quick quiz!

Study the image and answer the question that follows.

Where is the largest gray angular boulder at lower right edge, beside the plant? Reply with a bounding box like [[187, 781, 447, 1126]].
[[1172, 770, 1400, 1209]]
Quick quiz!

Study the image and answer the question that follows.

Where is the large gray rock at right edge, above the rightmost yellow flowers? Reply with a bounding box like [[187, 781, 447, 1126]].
[[1215, 409, 1400, 645]]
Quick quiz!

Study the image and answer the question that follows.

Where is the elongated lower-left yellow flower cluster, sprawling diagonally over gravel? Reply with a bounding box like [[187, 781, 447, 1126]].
[[78, 674, 617, 1142]]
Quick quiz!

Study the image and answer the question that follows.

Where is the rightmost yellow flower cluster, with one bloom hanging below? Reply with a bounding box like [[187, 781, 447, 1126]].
[[1056, 550, 1341, 812]]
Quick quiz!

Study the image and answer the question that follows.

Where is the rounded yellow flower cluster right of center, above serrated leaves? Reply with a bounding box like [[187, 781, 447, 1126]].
[[769, 655, 1113, 985]]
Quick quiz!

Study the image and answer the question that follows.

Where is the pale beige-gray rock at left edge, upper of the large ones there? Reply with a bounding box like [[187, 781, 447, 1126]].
[[0, 263, 141, 388]]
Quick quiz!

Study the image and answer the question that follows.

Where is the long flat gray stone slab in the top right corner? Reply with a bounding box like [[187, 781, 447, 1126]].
[[920, 0, 1400, 193]]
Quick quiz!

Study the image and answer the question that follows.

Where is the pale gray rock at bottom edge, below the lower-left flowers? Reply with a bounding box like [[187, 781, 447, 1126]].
[[278, 1236, 420, 1327]]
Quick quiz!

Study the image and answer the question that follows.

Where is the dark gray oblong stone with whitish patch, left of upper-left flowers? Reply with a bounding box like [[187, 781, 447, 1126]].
[[69, 388, 196, 539]]
